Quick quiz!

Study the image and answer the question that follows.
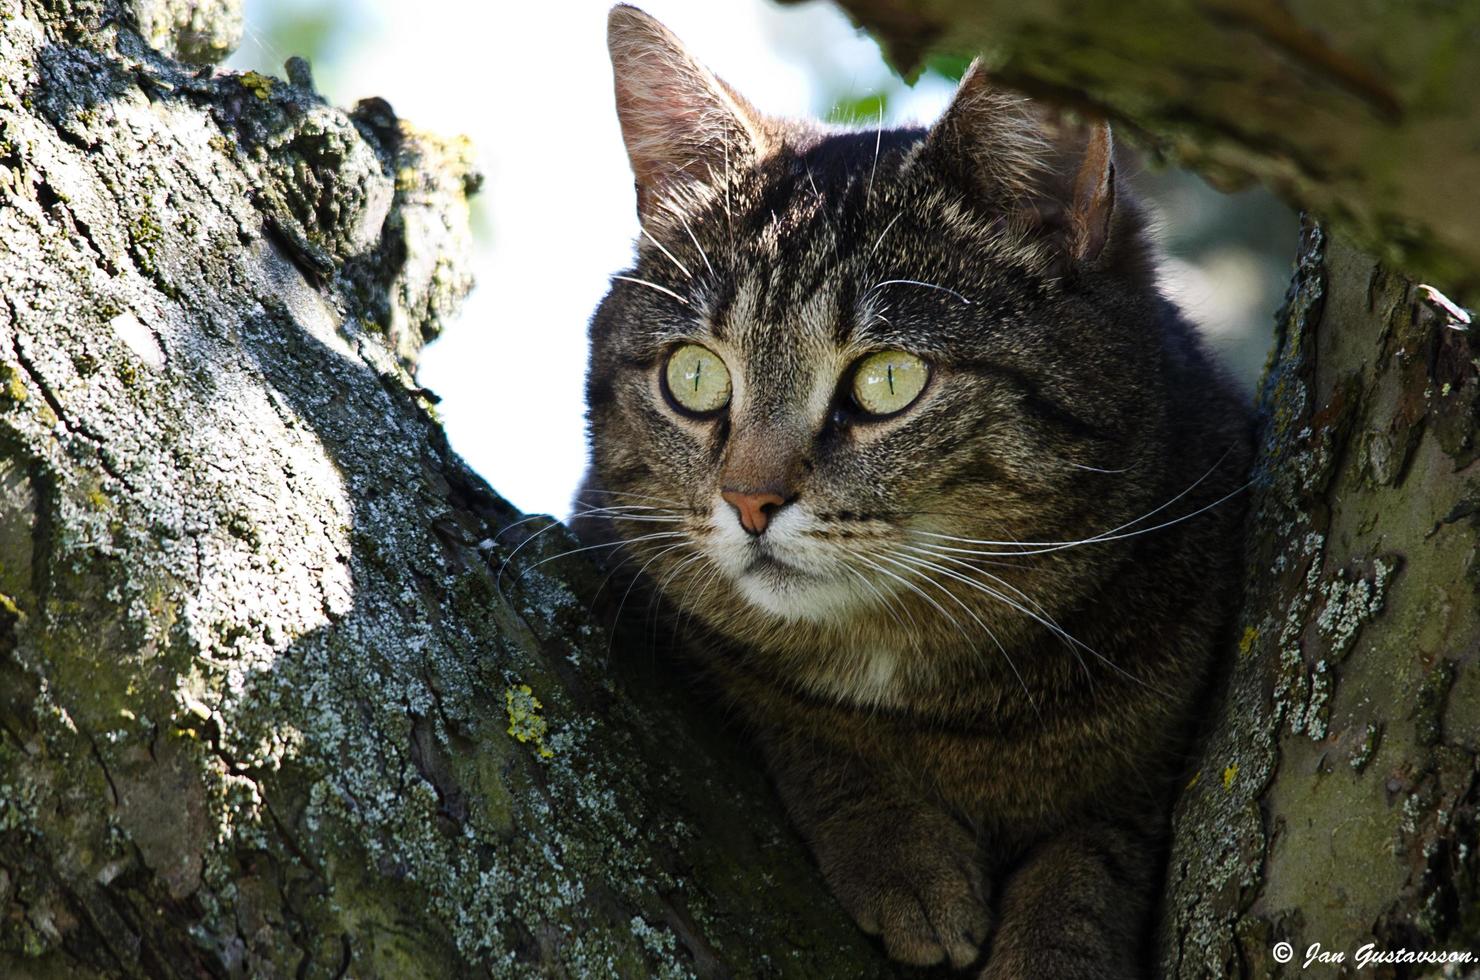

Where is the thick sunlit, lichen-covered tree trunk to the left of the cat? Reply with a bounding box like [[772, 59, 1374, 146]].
[[0, 0, 882, 979]]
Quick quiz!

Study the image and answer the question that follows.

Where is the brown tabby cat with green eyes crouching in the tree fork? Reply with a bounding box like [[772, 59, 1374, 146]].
[[573, 6, 1251, 980]]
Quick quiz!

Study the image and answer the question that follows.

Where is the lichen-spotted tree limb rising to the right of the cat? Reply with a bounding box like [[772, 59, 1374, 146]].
[[1160, 224, 1480, 977]]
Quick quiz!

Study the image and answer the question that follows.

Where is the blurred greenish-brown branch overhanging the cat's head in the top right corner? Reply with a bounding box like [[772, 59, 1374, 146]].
[[805, 0, 1480, 290]]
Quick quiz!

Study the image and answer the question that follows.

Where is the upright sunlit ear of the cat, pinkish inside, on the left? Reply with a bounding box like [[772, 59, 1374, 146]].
[[607, 4, 768, 222]]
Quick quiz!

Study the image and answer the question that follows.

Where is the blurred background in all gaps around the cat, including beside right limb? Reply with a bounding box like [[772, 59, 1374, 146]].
[[228, 0, 1296, 514]]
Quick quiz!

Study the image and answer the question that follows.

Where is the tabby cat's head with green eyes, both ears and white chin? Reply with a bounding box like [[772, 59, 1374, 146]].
[[577, 6, 1219, 680]]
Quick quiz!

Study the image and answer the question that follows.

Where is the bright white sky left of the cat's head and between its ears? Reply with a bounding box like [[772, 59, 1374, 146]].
[[231, 0, 950, 515]]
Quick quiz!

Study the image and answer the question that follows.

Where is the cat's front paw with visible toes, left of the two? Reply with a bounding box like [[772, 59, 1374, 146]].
[[829, 842, 992, 968]]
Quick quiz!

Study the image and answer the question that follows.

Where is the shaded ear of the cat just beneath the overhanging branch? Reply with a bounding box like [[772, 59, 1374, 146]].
[[926, 62, 1116, 264]]
